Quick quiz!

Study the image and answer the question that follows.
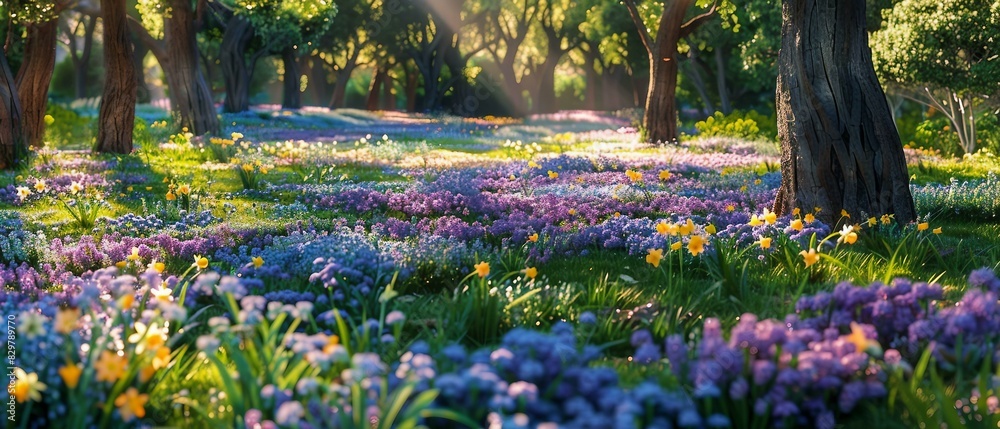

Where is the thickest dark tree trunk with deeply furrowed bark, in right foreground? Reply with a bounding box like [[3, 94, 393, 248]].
[[774, 0, 916, 224]]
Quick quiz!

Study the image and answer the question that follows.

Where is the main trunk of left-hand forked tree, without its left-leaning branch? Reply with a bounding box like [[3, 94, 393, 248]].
[[157, 0, 219, 135]]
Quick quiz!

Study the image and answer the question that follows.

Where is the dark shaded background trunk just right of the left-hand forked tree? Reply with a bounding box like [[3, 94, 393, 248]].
[[219, 15, 253, 113]]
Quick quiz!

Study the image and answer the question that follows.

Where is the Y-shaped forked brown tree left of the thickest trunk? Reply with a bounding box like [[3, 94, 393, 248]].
[[624, 0, 735, 143]]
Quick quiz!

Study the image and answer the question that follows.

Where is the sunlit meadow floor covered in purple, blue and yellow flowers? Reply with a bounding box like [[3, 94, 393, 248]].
[[0, 109, 1000, 428]]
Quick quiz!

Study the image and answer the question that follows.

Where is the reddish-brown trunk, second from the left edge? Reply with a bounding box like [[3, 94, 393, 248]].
[[15, 18, 59, 147]]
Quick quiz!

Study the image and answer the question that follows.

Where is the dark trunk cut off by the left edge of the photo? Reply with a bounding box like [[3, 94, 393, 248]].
[[0, 51, 28, 170]]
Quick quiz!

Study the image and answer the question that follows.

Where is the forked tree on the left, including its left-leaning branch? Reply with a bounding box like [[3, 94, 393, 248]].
[[129, 0, 219, 135]]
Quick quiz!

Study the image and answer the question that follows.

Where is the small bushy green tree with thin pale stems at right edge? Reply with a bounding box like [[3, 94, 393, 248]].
[[872, 0, 1000, 153]]
